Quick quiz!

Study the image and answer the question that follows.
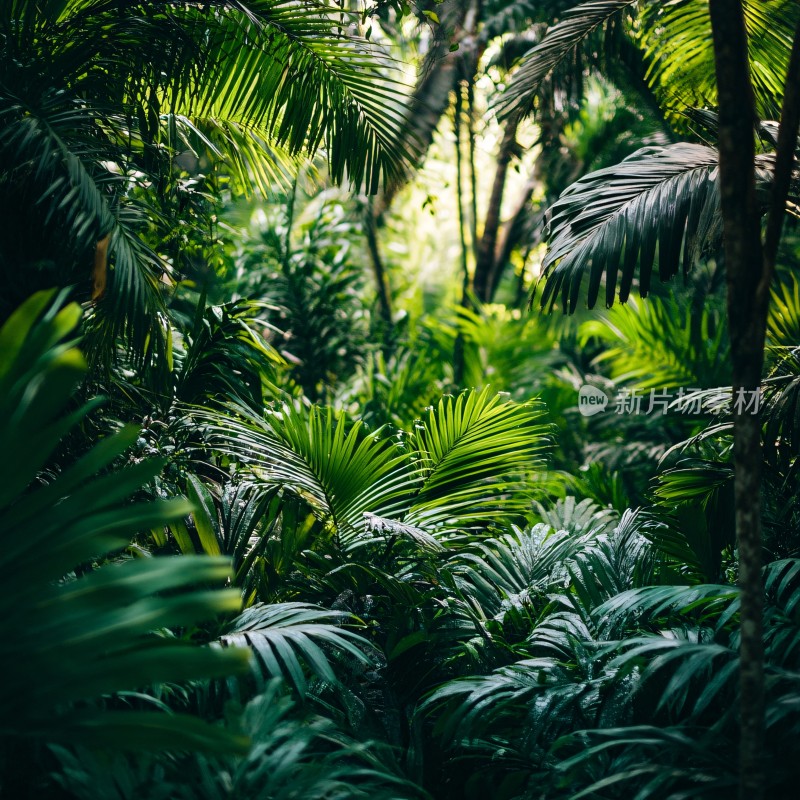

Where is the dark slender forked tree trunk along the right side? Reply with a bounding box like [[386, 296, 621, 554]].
[[709, 7, 800, 800]]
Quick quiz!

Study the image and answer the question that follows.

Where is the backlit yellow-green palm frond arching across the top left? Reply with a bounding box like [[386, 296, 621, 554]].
[[15, 0, 412, 191]]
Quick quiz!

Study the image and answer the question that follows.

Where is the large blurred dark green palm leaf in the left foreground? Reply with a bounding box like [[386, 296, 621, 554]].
[[0, 292, 247, 749]]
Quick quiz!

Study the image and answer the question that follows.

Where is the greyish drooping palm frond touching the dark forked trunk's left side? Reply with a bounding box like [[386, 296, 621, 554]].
[[541, 143, 772, 312]]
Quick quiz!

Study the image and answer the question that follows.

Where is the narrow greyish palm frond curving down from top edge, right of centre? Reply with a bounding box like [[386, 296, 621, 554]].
[[499, 0, 637, 115]]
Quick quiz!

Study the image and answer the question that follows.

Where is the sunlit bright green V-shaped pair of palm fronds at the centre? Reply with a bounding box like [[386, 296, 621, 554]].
[[196, 387, 550, 543]]
